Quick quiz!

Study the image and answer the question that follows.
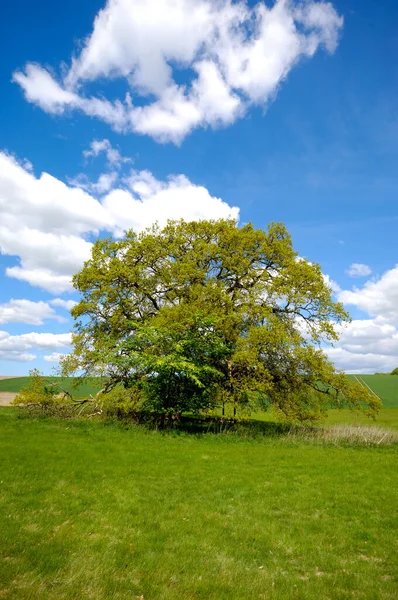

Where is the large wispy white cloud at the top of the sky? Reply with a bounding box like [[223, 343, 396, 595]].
[[14, 0, 343, 143]]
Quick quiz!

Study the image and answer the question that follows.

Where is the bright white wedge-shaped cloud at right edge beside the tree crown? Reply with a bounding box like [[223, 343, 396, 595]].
[[339, 265, 398, 325]]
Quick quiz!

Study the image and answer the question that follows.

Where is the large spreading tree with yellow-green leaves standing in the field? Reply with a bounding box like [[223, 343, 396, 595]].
[[64, 220, 379, 421]]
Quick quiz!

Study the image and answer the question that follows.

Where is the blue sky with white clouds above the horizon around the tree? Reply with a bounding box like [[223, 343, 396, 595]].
[[0, 0, 398, 375]]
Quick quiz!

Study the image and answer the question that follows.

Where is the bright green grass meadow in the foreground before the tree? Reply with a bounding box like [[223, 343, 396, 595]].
[[0, 408, 398, 600]]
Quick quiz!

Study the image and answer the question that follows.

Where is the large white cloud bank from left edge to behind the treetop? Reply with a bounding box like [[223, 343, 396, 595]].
[[0, 148, 239, 294]]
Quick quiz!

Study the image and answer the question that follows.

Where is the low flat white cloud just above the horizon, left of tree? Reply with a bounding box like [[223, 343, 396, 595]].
[[0, 331, 71, 362]]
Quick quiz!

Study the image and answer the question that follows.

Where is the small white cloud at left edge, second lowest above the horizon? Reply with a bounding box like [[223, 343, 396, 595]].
[[0, 298, 65, 325]]
